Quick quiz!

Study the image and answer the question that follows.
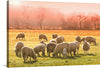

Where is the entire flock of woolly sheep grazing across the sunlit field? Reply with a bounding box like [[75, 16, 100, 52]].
[[15, 33, 96, 62]]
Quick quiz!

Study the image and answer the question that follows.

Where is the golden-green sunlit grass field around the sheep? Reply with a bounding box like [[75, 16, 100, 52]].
[[8, 30, 100, 67]]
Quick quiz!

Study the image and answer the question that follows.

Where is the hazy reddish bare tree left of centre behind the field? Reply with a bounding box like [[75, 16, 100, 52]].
[[38, 8, 45, 30]]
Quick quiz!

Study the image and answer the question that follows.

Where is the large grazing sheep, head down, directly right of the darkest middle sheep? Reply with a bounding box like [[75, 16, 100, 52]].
[[52, 43, 70, 57]]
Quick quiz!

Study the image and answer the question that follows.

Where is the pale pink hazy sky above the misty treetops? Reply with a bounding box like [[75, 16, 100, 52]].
[[10, 0, 100, 14]]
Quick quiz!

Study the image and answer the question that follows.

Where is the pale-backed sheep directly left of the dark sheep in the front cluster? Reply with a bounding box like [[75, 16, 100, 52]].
[[34, 41, 46, 56]]
